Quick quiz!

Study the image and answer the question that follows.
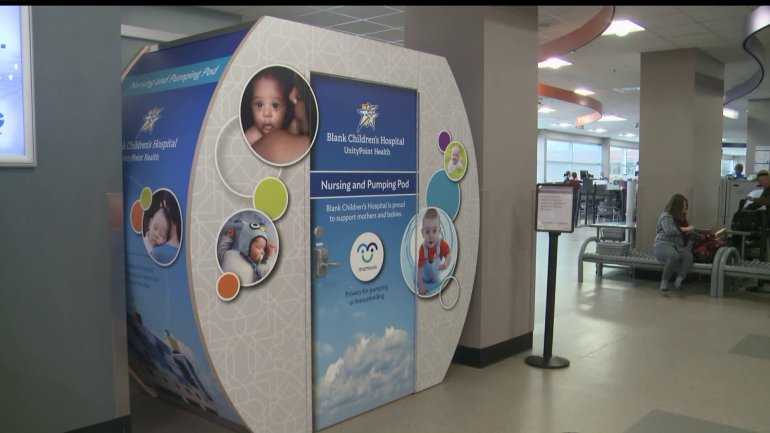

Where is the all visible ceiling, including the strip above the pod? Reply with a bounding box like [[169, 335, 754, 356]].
[[195, 6, 770, 142]]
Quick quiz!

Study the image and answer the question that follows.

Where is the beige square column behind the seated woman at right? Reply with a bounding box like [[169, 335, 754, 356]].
[[637, 49, 724, 248]]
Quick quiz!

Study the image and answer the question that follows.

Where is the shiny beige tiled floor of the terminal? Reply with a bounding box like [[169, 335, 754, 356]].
[[133, 229, 770, 433]]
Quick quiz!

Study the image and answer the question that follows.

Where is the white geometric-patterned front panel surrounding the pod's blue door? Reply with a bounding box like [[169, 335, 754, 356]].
[[188, 17, 479, 432]]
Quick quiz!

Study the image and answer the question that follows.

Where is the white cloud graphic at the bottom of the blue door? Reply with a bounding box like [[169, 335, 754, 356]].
[[316, 326, 414, 428]]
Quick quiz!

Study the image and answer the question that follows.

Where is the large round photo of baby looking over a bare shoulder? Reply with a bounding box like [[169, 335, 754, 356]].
[[239, 65, 318, 167]]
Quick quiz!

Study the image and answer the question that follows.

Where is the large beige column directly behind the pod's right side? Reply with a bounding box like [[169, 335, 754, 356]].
[[404, 6, 537, 366]]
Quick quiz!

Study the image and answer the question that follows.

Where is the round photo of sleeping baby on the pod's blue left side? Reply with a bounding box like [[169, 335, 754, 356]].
[[141, 188, 184, 267]]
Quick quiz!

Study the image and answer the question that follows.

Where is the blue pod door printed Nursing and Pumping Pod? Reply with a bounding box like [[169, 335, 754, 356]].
[[310, 74, 417, 429]]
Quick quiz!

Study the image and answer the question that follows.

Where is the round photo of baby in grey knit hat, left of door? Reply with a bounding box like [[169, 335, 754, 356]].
[[214, 209, 280, 287]]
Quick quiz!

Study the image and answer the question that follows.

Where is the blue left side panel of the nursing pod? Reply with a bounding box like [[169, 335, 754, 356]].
[[123, 30, 246, 427]]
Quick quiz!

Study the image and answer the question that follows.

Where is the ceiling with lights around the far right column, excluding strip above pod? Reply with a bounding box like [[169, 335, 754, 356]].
[[538, 6, 770, 142]]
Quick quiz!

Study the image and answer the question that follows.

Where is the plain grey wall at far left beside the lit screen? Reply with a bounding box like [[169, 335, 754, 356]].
[[0, 6, 128, 433]]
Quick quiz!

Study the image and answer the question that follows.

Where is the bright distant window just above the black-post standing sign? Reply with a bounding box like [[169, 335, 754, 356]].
[[545, 138, 602, 182]]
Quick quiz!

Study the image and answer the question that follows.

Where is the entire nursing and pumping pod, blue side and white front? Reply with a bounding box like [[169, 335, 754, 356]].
[[123, 17, 479, 432]]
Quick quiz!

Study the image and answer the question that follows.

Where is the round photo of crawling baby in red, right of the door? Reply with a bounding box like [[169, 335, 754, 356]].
[[401, 207, 460, 298]]
